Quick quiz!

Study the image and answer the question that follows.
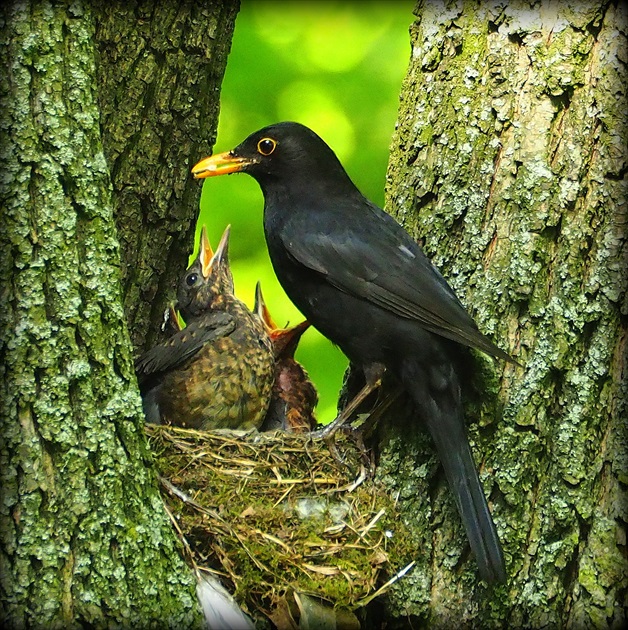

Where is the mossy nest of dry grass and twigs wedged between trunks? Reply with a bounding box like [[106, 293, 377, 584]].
[[146, 425, 412, 625]]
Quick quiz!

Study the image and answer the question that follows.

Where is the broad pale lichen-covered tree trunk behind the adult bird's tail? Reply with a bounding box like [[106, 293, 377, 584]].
[[380, 2, 628, 628]]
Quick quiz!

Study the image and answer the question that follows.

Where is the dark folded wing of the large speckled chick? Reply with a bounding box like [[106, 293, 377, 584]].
[[135, 311, 236, 383]]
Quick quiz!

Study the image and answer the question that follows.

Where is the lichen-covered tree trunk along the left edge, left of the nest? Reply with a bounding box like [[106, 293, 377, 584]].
[[0, 2, 237, 628]]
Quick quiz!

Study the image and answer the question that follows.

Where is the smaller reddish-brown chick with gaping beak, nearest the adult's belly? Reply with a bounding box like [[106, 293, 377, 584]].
[[254, 282, 318, 433]]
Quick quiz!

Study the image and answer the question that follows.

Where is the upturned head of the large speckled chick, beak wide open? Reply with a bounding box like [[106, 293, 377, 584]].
[[177, 226, 234, 320]]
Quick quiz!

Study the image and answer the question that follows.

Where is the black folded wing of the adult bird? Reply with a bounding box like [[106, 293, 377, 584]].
[[283, 205, 512, 361]]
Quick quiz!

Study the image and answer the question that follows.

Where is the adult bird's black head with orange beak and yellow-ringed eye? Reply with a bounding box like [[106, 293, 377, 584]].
[[192, 122, 350, 191]]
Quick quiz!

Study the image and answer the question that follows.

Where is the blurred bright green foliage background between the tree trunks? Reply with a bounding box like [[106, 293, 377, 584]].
[[196, 0, 414, 422]]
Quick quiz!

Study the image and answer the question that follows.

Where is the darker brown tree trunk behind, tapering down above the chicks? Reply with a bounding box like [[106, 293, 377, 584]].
[[95, 0, 239, 349]]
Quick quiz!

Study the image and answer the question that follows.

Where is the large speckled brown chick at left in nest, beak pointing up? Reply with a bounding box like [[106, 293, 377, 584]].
[[135, 227, 274, 430]]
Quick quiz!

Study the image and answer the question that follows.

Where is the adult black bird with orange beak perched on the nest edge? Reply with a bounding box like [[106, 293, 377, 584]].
[[192, 122, 512, 582]]
